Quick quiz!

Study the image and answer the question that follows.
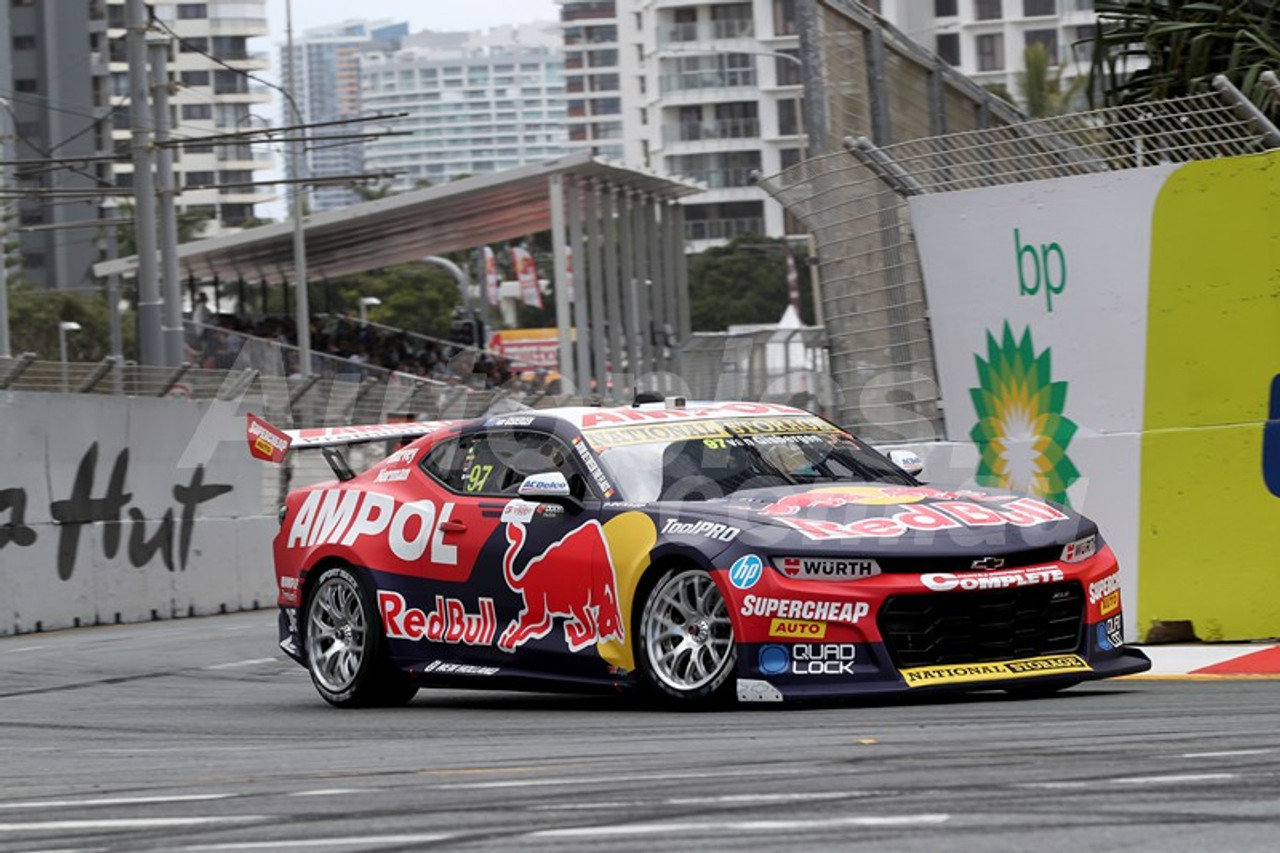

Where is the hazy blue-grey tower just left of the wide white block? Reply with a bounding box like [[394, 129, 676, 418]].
[[279, 20, 408, 211]]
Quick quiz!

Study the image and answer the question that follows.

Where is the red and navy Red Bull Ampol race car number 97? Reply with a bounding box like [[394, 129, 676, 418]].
[[248, 398, 1149, 706]]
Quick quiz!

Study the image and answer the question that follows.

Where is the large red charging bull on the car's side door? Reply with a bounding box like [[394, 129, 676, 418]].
[[498, 521, 625, 652]]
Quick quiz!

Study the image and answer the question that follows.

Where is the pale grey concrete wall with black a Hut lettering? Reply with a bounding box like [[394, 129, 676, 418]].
[[0, 393, 275, 634]]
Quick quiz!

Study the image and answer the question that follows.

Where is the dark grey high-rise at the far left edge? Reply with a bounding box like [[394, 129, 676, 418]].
[[0, 0, 111, 289]]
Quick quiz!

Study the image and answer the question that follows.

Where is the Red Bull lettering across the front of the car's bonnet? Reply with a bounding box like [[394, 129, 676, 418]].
[[780, 497, 1068, 540]]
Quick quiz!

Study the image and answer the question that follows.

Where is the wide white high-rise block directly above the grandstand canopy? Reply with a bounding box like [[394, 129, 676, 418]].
[[361, 23, 568, 191]]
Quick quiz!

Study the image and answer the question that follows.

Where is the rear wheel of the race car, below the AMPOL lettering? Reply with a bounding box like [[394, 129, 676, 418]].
[[303, 565, 417, 708]]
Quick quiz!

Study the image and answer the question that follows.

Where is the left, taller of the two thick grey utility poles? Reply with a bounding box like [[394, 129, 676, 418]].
[[124, 0, 165, 365]]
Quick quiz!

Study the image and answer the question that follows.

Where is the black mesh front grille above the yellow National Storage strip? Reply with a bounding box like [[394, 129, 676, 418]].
[[877, 581, 1084, 669]]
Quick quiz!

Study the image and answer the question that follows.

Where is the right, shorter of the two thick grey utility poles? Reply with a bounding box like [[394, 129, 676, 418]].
[[147, 36, 184, 368]]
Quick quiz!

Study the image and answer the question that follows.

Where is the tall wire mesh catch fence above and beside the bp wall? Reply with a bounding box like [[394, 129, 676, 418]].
[[760, 0, 1280, 442]]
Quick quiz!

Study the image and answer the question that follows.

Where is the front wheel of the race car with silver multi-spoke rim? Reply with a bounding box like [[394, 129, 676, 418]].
[[636, 566, 737, 708]]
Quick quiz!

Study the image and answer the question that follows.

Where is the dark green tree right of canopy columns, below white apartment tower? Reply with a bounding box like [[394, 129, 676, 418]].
[[689, 234, 814, 332]]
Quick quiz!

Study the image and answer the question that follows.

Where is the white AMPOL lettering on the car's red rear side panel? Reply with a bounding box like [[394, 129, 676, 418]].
[[284, 489, 458, 566]]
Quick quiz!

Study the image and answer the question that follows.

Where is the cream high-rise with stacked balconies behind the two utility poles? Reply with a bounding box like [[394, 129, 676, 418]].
[[106, 0, 275, 237]]
